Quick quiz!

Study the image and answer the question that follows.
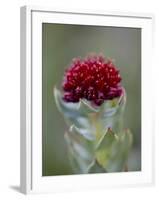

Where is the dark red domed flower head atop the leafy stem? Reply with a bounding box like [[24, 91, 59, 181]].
[[62, 55, 122, 105]]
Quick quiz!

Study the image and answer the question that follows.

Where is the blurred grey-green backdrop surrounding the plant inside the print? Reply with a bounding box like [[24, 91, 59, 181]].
[[42, 23, 141, 176]]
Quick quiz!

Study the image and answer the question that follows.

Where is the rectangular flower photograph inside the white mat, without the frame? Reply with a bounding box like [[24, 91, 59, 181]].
[[42, 23, 142, 176]]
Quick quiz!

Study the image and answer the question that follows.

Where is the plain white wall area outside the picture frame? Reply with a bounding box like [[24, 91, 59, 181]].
[[0, 0, 159, 200]]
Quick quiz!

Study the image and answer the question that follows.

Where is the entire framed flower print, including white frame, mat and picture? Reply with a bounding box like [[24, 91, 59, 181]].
[[21, 6, 154, 193]]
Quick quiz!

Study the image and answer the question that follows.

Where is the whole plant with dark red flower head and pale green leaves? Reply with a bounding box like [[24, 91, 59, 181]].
[[54, 55, 132, 174]]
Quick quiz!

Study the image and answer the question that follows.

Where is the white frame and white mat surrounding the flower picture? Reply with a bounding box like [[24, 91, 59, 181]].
[[21, 6, 154, 194]]
